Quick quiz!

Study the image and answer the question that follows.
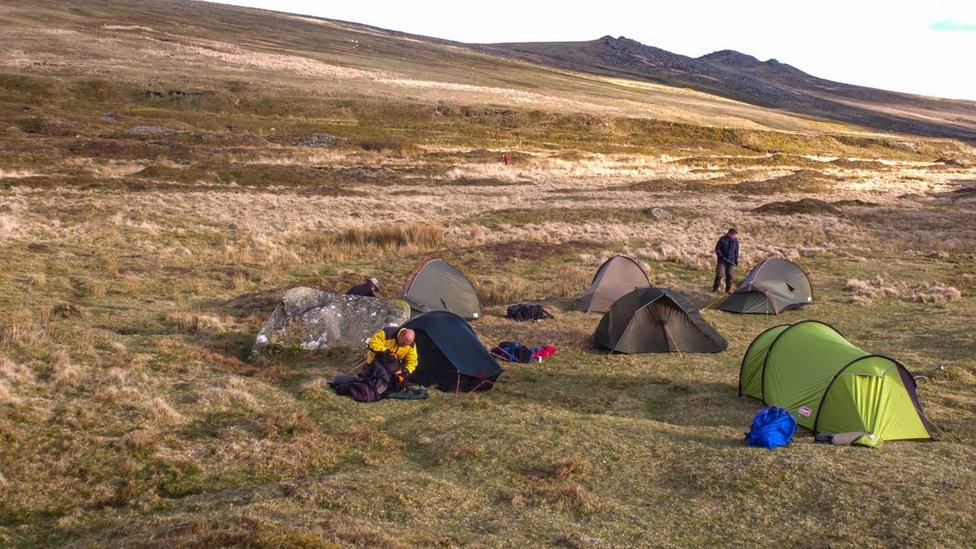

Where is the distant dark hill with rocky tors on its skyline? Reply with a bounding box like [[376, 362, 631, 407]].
[[480, 36, 976, 143]]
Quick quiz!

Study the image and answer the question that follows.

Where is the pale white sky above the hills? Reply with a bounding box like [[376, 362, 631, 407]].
[[206, 0, 976, 100]]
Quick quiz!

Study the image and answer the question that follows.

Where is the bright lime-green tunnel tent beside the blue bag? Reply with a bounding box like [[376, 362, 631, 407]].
[[739, 320, 934, 447]]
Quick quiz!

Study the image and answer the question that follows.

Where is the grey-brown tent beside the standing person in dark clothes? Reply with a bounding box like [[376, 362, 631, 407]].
[[717, 257, 813, 315]]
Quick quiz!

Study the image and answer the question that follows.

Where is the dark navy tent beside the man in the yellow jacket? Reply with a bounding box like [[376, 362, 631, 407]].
[[403, 311, 502, 392]]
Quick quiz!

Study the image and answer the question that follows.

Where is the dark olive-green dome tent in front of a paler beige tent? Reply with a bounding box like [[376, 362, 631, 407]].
[[593, 288, 729, 353]]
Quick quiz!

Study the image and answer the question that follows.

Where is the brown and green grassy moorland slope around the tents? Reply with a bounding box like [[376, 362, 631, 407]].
[[0, 2, 976, 547]]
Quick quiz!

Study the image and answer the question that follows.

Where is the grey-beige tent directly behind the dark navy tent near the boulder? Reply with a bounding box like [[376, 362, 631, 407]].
[[403, 258, 481, 320]]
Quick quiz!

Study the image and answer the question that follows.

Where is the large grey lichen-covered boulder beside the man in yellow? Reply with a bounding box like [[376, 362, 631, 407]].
[[252, 287, 410, 355]]
